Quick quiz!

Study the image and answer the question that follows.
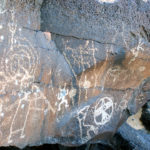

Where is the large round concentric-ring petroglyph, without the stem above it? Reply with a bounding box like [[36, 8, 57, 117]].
[[0, 39, 38, 84]]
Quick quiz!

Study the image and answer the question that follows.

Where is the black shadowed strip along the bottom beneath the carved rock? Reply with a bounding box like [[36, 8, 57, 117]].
[[1, 133, 135, 150]]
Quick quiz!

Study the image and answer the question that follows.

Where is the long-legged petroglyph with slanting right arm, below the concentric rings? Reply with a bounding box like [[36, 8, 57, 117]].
[[8, 85, 55, 143]]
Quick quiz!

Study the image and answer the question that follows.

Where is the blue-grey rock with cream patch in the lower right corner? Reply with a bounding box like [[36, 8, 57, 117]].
[[118, 111, 150, 150]]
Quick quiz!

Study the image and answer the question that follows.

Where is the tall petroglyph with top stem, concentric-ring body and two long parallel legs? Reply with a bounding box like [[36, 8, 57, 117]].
[[1, 9, 38, 143]]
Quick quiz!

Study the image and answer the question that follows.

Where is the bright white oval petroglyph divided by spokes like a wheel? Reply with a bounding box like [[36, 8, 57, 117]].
[[94, 97, 113, 125]]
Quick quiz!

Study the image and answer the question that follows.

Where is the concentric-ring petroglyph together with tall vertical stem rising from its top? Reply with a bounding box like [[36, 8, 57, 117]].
[[0, 10, 38, 92]]
